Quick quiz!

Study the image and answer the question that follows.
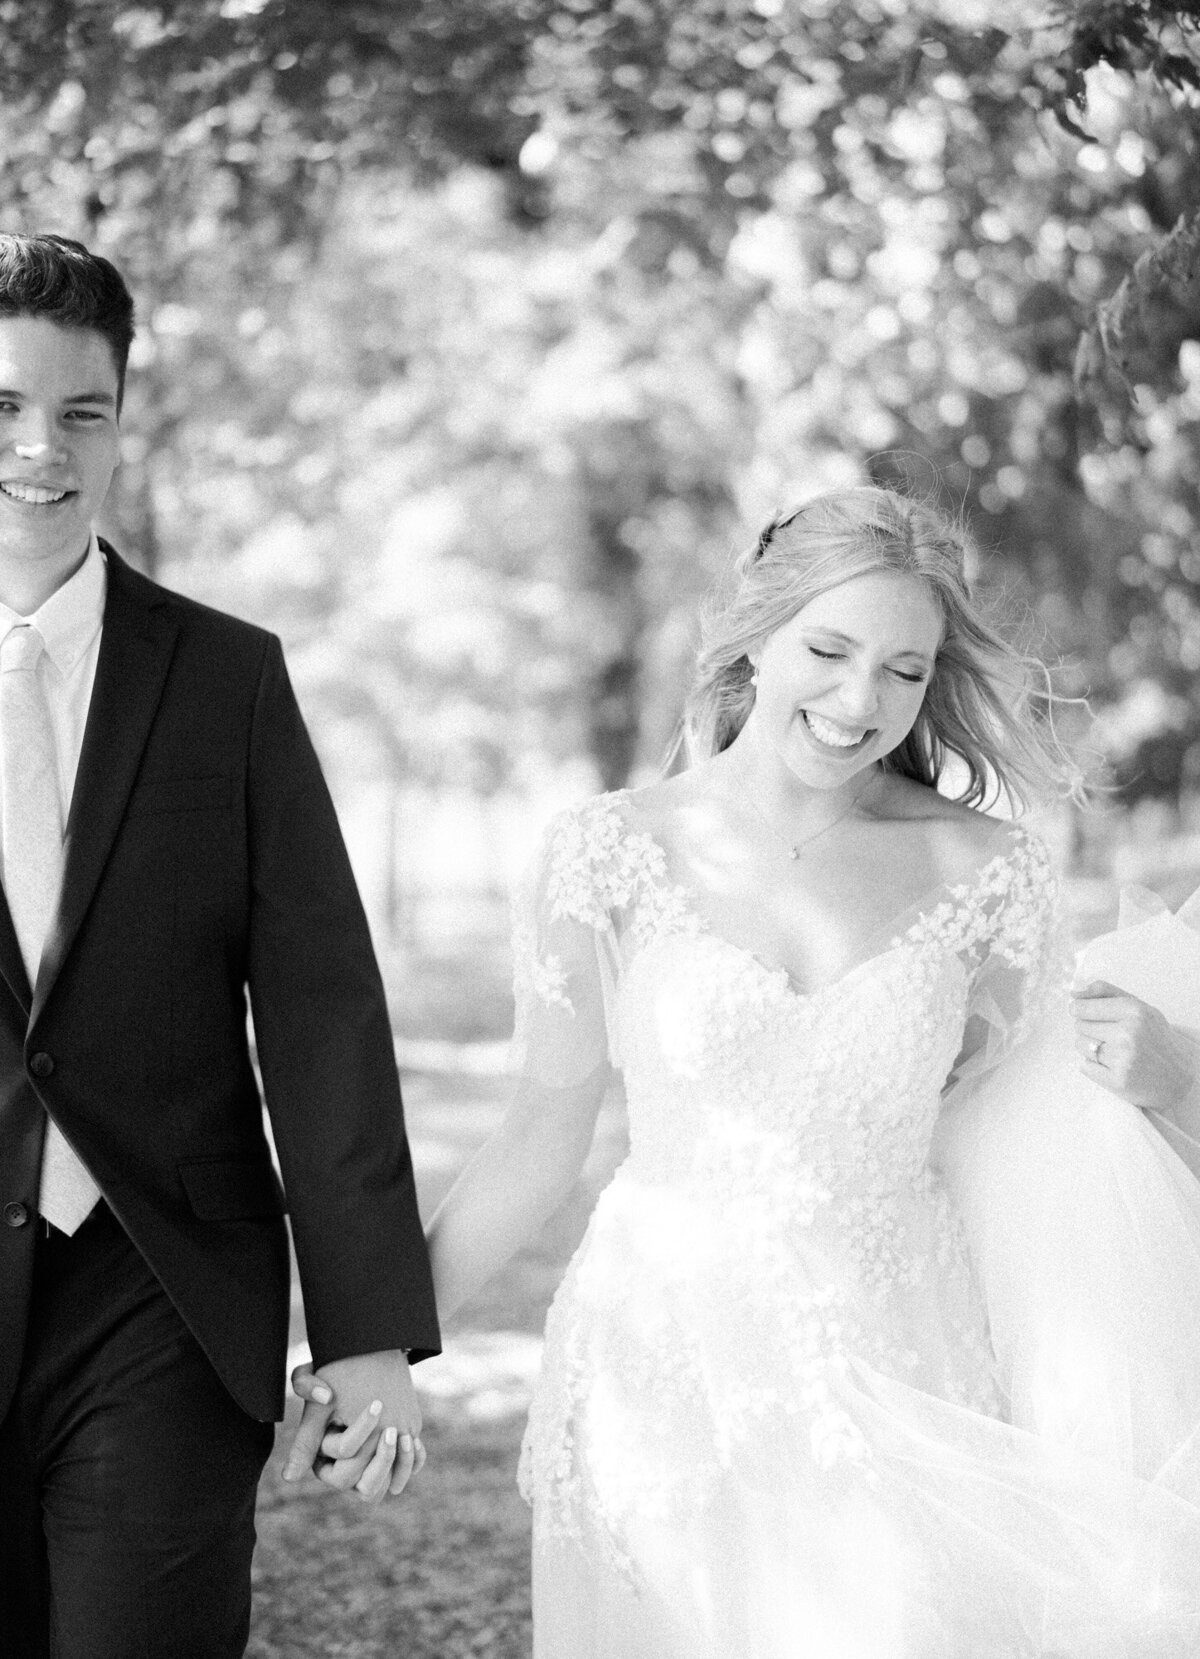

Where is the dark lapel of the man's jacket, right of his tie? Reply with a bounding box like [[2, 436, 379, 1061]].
[[31, 546, 178, 1020]]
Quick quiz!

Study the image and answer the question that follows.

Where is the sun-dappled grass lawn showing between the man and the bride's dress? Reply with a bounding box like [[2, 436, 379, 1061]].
[[247, 1075, 622, 1659]]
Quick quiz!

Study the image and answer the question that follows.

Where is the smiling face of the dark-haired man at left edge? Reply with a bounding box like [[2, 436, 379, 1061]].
[[0, 317, 118, 581]]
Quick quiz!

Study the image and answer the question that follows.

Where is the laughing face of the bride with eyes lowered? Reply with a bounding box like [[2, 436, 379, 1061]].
[[747, 571, 943, 790]]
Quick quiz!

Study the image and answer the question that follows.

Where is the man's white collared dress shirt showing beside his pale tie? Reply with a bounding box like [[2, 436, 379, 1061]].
[[0, 531, 108, 842]]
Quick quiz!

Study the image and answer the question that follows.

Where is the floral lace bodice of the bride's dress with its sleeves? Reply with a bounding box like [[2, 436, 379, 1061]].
[[526, 793, 1054, 1234]]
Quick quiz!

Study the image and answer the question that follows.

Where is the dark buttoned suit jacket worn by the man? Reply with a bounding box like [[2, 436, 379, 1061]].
[[0, 547, 438, 1420]]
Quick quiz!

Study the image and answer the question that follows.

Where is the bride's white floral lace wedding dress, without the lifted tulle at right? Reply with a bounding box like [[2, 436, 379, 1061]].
[[516, 793, 1200, 1659]]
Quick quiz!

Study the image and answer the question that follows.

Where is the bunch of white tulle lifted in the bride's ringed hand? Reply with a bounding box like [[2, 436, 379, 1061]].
[[934, 901, 1200, 1503]]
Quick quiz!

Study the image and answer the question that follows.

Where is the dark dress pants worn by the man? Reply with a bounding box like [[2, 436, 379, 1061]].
[[0, 1204, 274, 1659]]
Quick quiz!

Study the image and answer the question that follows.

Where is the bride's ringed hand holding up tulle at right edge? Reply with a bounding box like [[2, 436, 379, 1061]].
[[1071, 979, 1197, 1112]]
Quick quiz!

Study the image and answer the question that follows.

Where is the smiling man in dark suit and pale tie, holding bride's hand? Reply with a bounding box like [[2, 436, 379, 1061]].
[[0, 236, 438, 1659]]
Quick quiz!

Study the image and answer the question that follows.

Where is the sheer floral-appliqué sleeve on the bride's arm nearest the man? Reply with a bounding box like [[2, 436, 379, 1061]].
[[511, 796, 626, 1088]]
